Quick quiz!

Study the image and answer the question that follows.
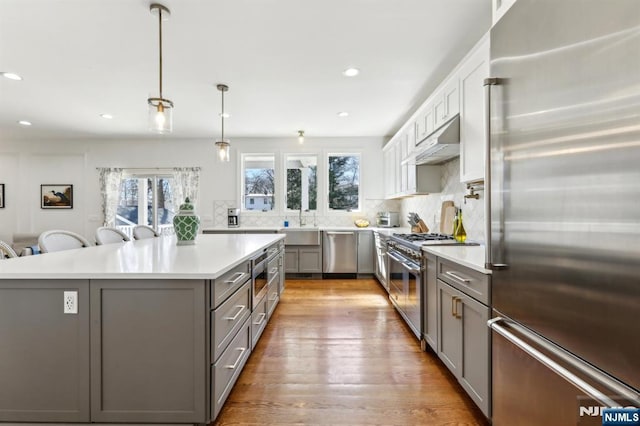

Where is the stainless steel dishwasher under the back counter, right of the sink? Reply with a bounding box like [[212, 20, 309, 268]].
[[322, 231, 358, 274]]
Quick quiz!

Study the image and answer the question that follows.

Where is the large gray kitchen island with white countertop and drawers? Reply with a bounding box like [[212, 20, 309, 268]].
[[0, 234, 284, 423]]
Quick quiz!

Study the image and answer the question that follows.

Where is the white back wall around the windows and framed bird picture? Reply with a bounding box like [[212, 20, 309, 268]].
[[0, 137, 399, 242]]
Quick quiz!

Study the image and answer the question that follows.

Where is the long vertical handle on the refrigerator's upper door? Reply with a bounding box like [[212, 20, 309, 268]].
[[484, 77, 507, 270]]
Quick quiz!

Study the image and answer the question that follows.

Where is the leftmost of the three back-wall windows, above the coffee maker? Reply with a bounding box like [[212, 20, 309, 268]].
[[242, 154, 276, 212]]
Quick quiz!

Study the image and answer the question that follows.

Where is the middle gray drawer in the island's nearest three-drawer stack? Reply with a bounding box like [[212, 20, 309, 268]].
[[211, 283, 251, 360]]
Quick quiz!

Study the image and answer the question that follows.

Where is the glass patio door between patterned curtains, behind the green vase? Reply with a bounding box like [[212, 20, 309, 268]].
[[116, 175, 176, 232]]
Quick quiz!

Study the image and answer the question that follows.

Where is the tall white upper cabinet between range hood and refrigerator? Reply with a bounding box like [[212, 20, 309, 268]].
[[459, 35, 489, 182]]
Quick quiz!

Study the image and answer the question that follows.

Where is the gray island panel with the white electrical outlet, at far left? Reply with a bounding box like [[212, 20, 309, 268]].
[[0, 280, 90, 422]]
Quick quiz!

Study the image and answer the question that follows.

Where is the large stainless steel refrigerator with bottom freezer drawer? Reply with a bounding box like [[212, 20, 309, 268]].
[[485, 0, 640, 426]]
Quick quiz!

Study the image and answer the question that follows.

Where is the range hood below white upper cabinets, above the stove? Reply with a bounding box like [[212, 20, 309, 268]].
[[416, 114, 460, 164]]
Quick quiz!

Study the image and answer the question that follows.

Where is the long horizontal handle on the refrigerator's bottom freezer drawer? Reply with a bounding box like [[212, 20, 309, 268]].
[[487, 317, 640, 407]]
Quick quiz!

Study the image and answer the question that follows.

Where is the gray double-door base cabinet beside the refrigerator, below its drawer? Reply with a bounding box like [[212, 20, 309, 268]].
[[437, 280, 491, 417]]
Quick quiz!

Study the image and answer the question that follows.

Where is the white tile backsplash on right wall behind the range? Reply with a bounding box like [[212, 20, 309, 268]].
[[400, 157, 485, 242]]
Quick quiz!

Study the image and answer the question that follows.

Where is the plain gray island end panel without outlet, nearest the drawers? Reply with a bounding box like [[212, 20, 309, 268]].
[[91, 280, 207, 423]]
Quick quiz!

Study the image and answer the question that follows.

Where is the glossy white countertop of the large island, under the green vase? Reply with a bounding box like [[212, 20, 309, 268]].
[[0, 234, 285, 279]]
